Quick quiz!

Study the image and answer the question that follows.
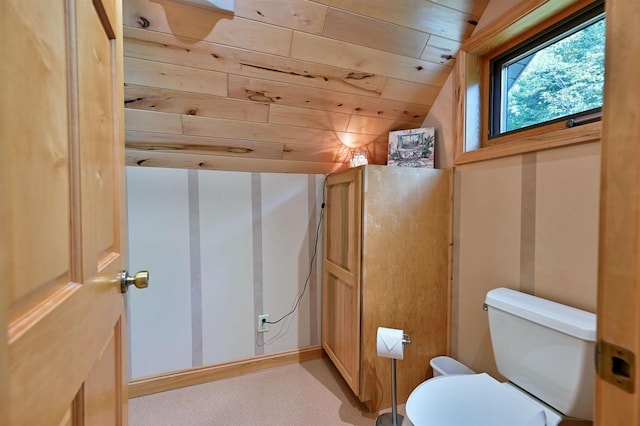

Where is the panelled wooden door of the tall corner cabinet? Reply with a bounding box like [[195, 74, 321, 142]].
[[322, 168, 362, 396]]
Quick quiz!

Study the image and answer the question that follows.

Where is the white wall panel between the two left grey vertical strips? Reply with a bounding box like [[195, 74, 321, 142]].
[[198, 172, 256, 367]]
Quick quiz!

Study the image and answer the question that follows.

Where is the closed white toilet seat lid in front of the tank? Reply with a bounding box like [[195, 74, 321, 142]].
[[406, 373, 559, 426]]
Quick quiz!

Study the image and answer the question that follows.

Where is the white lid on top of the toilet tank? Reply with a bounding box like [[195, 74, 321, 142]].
[[485, 287, 596, 342]]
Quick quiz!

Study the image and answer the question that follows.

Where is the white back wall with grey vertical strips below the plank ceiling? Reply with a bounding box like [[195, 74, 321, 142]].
[[127, 167, 324, 378]]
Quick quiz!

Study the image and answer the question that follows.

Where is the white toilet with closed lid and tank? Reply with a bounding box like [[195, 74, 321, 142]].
[[406, 288, 596, 426]]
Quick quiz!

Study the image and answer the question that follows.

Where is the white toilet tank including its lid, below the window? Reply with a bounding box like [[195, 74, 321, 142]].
[[485, 288, 596, 420]]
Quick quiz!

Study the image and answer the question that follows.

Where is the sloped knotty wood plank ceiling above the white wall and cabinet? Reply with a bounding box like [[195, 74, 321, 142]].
[[123, 0, 488, 173]]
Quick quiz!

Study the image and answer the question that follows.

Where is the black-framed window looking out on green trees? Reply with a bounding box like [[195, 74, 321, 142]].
[[488, 1, 605, 138]]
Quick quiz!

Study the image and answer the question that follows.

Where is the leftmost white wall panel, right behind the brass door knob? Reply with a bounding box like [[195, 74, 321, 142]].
[[127, 168, 191, 377]]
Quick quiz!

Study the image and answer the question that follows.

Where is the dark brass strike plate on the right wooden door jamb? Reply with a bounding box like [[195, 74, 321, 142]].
[[596, 340, 636, 393]]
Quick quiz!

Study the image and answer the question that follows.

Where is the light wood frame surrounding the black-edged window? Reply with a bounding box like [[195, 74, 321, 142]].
[[454, 0, 602, 165]]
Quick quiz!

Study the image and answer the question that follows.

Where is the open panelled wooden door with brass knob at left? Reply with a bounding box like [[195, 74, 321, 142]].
[[0, 0, 127, 426]]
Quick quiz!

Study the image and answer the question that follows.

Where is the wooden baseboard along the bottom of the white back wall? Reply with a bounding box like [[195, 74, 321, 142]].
[[129, 345, 325, 398]]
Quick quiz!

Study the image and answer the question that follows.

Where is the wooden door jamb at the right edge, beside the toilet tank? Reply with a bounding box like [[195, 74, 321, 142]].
[[595, 0, 640, 426]]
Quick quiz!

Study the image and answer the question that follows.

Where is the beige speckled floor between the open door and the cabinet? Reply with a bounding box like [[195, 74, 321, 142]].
[[129, 358, 410, 426]]
